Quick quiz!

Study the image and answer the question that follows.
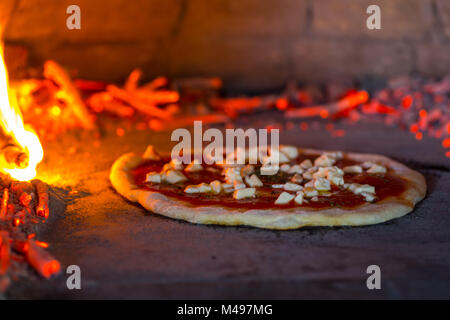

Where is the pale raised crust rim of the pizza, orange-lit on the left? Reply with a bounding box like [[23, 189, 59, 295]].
[[110, 149, 426, 230]]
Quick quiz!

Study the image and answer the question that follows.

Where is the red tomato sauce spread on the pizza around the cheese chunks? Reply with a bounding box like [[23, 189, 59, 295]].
[[132, 155, 406, 209]]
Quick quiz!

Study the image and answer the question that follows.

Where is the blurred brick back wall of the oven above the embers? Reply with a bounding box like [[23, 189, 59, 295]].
[[0, 0, 450, 89]]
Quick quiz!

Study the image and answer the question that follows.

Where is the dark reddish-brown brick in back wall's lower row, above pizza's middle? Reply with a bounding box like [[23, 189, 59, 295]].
[[170, 38, 289, 90]]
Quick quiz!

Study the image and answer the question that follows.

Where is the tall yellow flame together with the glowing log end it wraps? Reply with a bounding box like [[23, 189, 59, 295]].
[[0, 44, 44, 181]]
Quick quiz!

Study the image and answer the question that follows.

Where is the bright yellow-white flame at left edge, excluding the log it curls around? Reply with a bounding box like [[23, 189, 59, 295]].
[[0, 43, 44, 181]]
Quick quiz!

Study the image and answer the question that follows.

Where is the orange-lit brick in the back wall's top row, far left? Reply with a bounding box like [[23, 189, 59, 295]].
[[6, 0, 181, 43]]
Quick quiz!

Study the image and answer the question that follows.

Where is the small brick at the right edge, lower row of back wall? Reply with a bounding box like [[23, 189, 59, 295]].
[[416, 43, 450, 76]]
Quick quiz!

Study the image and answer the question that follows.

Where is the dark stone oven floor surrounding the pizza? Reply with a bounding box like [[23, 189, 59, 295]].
[[7, 121, 450, 299]]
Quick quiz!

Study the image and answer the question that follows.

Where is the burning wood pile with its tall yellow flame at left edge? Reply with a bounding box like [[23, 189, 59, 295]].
[[0, 37, 60, 293]]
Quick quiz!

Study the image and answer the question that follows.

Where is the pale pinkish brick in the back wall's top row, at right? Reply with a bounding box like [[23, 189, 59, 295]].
[[312, 0, 433, 39]]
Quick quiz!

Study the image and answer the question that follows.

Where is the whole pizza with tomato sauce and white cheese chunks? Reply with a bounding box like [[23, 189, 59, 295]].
[[110, 146, 426, 230]]
